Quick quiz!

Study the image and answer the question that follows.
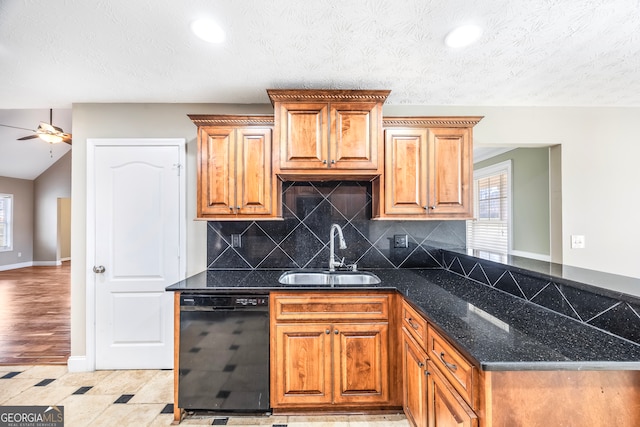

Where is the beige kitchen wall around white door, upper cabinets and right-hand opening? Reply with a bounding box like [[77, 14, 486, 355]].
[[71, 102, 640, 362]]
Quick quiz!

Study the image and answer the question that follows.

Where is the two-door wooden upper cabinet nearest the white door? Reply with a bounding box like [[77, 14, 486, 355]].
[[189, 115, 281, 220]]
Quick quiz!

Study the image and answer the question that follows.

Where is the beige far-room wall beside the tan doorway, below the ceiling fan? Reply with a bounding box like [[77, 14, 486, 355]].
[[33, 150, 73, 265]]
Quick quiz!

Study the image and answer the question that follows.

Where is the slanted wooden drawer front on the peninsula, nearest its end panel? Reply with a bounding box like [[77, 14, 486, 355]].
[[427, 326, 476, 407]]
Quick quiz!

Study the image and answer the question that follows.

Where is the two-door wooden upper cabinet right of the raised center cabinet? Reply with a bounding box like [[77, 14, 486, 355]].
[[373, 117, 482, 219]]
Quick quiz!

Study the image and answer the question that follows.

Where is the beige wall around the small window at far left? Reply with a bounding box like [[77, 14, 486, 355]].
[[0, 176, 33, 270]]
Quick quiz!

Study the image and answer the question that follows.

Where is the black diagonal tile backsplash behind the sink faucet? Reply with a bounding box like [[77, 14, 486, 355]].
[[207, 181, 465, 269]]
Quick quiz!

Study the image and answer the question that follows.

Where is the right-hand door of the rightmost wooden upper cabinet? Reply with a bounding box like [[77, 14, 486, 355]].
[[428, 128, 473, 218]]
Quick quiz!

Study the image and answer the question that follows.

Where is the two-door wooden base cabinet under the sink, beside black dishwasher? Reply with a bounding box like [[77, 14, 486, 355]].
[[271, 293, 392, 409]]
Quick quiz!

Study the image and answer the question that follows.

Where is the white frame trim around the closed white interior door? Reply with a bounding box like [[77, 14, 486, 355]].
[[82, 138, 187, 371]]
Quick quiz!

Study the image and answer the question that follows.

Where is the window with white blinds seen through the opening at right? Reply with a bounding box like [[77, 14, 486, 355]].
[[467, 161, 511, 254]]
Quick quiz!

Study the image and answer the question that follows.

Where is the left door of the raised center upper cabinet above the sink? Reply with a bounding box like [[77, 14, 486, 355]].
[[276, 102, 329, 169]]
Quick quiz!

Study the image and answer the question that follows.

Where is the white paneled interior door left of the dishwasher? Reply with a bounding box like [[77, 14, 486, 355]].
[[88, 140, 184, 369]]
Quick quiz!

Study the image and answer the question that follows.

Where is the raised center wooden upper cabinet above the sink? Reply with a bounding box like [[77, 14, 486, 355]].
[[267, 89, 390, 179]]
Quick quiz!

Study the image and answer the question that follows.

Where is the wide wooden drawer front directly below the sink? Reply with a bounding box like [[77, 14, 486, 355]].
[[271, 293, 389, 322]]
